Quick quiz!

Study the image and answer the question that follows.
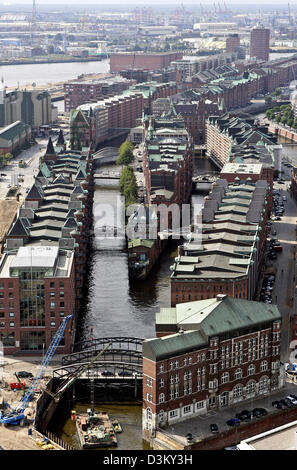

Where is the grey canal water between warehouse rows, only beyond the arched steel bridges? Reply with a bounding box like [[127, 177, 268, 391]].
[[80, 158, 213, 340]]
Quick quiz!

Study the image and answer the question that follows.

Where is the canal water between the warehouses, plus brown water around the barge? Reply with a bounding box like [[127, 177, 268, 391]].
[[51, 158, 214, 450]]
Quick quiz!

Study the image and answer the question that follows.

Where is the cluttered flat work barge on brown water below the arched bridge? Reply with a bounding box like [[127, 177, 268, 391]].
[[76, 409, 118, 449]]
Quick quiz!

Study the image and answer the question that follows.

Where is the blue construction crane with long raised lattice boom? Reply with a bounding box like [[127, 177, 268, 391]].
[[0, 315, 73, 426]]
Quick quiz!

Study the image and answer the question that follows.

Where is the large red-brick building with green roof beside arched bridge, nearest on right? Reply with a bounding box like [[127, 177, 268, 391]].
[[142, 296, 283, 440]]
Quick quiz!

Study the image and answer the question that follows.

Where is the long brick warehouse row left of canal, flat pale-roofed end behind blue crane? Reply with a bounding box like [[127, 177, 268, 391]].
[[0, 141, 93, 354]]
